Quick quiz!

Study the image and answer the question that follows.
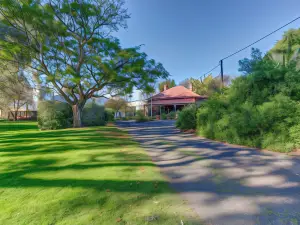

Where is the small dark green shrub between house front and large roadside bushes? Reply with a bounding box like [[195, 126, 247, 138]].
[[176, 104, 197, 130]]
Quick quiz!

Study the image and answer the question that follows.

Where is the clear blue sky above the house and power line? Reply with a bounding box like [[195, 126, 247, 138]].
[[116, 0, 300, 83]]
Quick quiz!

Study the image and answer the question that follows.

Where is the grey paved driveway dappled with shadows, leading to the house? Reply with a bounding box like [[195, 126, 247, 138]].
[[119, 121, 300, 225]]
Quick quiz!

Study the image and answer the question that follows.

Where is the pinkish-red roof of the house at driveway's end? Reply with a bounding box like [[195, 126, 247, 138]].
[[152, 86, 206, 100]]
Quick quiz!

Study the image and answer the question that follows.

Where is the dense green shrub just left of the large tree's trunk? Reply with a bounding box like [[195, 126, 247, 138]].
[[38, 101, 73, 130]]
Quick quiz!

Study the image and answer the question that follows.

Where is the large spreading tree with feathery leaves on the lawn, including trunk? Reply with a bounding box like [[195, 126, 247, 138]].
[[0, 0, 168, 127]]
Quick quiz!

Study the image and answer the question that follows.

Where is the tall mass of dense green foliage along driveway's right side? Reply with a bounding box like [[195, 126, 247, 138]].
[[197, 59, 300, 152]]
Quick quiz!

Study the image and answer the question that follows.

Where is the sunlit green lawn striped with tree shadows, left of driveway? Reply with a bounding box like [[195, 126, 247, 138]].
[[0, 122, 199, 225]]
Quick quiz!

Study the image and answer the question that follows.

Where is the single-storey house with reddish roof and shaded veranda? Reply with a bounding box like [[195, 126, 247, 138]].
[[144, 85, 207, 116]]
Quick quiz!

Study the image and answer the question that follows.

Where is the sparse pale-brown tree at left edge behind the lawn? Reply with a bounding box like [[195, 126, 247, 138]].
[[0, 65, 33, 120]]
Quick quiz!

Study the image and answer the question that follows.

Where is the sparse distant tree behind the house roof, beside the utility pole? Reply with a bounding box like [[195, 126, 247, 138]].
[[191, 74, 230, 96]]
